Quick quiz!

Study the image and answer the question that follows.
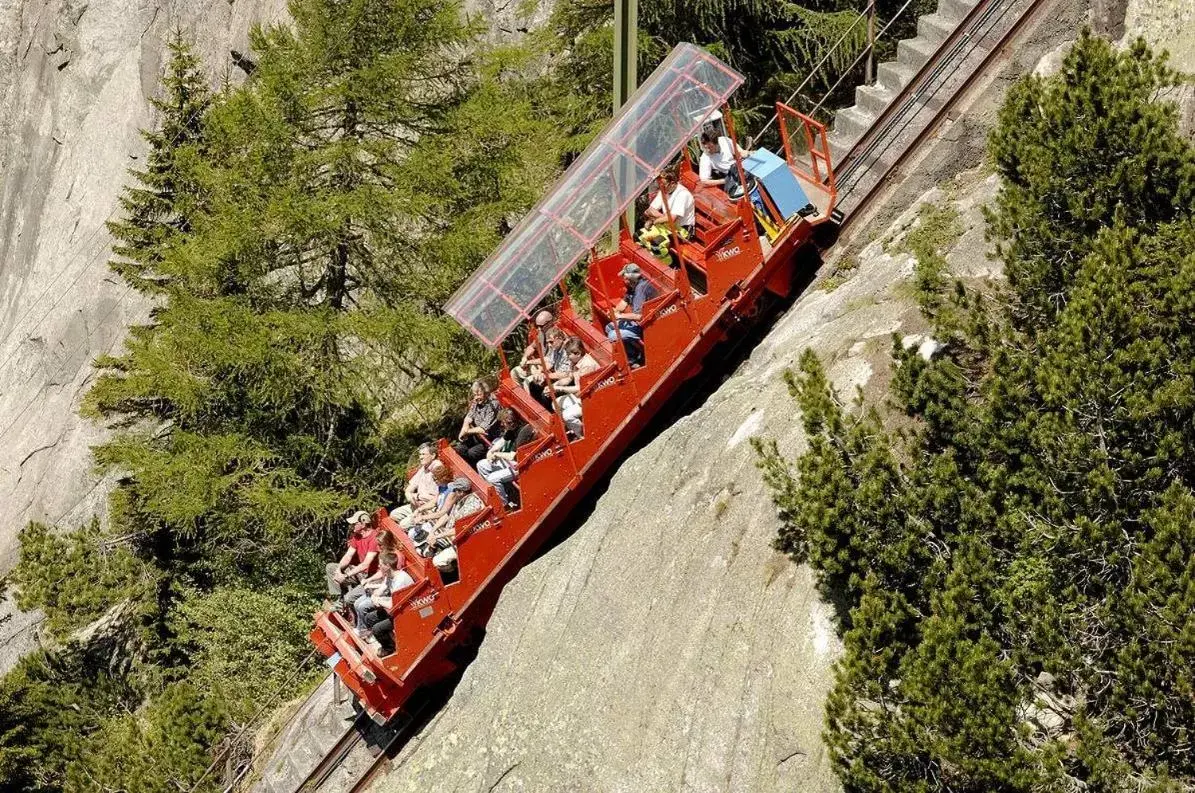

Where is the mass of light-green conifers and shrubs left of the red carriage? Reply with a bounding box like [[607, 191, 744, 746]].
[[0, 0, 582, 791]]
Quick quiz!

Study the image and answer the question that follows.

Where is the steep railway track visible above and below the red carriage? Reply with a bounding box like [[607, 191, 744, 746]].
[[284, 0, 1052, 793]]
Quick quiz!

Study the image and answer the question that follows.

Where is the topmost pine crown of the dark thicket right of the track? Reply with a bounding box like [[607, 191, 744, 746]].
[[989, 32, 1195, 327]]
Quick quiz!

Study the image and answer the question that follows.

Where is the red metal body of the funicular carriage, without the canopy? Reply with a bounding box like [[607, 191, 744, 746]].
[[311, 91, 834, 721]]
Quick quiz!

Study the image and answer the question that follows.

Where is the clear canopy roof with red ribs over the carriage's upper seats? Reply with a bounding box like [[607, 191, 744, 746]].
[[445, 44, 743, 348]]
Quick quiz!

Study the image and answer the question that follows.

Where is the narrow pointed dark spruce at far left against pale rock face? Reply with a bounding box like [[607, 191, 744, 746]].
[[108, 29, 213, 293]]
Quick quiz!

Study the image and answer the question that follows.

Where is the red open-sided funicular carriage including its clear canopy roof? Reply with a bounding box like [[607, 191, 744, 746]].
[[311, 44, 835, 723]]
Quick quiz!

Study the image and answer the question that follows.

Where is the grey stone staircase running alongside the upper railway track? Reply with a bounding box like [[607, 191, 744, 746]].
[[828, 0, 979, 162]]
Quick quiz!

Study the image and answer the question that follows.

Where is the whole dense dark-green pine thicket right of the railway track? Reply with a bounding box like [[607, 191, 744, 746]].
[[756, 37, 1195, 793]]
